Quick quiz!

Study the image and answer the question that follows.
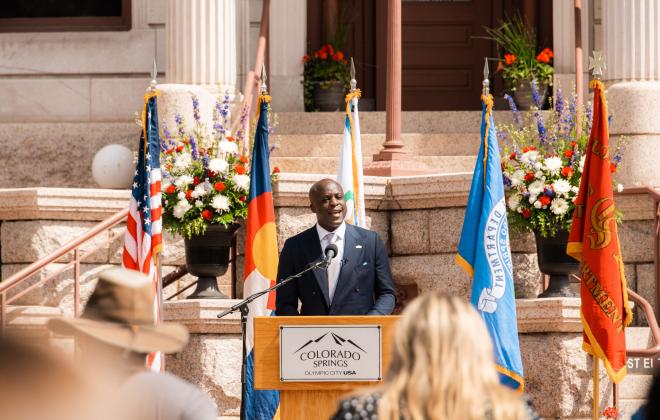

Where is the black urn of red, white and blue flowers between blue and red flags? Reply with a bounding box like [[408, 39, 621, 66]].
[[497, 81, 624, 297]]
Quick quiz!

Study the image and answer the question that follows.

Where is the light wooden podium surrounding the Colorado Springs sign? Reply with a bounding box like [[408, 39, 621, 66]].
[[254, 316, 399, 420]]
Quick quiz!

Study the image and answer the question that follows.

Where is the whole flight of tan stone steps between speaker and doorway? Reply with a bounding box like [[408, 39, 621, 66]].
[[270, 111, 511, 174]]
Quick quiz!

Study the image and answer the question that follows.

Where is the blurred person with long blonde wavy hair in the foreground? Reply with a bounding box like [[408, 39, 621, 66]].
[[332, 292, 533, 420]]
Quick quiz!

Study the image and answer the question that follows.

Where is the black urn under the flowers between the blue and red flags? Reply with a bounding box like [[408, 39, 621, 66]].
[[534, 230, 580, 298]]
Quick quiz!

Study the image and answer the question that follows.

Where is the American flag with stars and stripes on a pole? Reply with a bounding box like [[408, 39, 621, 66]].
[[122, 93, 163, 371]]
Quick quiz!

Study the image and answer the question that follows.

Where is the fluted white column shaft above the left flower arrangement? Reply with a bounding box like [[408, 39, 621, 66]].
[[166, 0, 237, 93]]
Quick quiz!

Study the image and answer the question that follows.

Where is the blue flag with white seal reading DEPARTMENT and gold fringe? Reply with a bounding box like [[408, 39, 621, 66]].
[[456, 95, 525, 391]]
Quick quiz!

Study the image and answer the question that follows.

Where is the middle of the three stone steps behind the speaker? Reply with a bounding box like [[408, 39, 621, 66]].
[[270, 133, 480, 158]]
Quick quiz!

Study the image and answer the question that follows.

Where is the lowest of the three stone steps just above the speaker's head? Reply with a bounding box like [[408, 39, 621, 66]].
[[270, 156, 476, 175]]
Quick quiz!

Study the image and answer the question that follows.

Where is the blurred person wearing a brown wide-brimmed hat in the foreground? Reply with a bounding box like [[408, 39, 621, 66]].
[[48, 268, 218, 420]]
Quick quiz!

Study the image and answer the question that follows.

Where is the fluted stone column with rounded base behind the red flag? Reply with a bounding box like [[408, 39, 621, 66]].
[[603, 0, 660, 187]]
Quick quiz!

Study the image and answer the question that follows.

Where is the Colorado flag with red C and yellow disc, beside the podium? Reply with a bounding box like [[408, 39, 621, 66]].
[[243, 94, 280, 420]]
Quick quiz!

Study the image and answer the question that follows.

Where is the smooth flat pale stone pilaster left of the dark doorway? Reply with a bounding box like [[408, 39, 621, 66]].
[[267, 0, 307, 111]]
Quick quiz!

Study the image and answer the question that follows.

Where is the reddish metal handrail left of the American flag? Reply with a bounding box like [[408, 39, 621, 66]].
[[0, 208, 128, 330]]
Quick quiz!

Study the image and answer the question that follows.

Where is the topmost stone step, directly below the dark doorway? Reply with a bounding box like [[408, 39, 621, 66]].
[[275, 110, 512, 134]]
